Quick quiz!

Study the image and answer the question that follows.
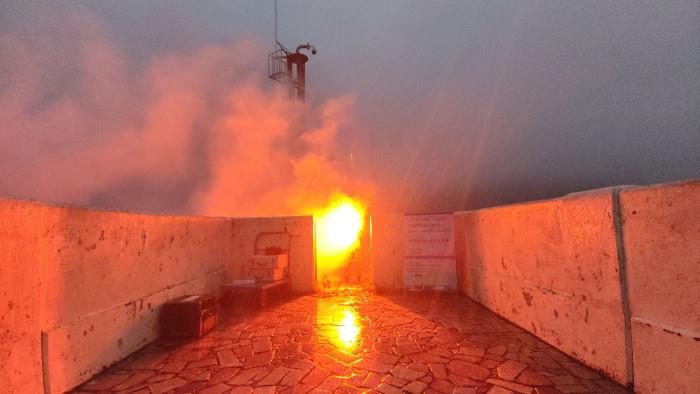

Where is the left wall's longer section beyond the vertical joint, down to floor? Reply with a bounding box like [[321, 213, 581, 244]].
[[40, 207, 232, 392]]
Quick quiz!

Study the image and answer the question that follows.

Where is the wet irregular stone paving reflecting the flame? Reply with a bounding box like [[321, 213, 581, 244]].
[[75, 290, 626, 394]]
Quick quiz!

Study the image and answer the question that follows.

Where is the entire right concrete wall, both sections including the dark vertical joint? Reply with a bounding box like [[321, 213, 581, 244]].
[[455, 181, 700, 393]]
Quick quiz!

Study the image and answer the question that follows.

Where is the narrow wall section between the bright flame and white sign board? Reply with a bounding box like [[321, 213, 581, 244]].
[[372, 212, 404, 292]]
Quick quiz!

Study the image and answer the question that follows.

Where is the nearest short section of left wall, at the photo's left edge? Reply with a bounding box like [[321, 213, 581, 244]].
[[0, 200, 43, 393]]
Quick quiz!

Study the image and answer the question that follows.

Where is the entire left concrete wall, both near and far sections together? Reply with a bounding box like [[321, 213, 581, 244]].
[[0, 200, 233, 393]]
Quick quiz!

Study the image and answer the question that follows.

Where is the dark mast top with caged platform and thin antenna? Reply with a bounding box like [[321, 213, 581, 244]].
[[267, 0, 316, 101]]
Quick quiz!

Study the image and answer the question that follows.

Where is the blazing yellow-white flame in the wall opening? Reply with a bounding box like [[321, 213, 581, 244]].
[[316, 195, 365, 273]]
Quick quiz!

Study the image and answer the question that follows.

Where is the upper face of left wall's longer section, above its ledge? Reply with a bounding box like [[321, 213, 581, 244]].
[[41, 207, 231, 327]]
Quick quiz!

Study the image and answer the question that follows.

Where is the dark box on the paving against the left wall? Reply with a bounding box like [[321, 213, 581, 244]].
[[160, 295, 219, 339]]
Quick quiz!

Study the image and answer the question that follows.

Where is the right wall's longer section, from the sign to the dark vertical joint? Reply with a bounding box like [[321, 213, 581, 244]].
[[456, 189, 627, 383]]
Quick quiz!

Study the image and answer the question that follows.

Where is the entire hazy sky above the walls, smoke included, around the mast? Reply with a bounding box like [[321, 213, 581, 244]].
[[0, 0, 700, 215]]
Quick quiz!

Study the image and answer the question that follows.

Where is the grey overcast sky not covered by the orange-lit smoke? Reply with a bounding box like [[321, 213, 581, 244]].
[[0, 0, 700, 211]]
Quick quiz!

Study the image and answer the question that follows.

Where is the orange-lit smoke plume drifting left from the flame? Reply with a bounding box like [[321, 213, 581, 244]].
[[0, 5, 371, 215]]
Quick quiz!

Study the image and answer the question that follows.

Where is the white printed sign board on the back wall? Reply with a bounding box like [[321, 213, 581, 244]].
[[403, 214, 457, 290]]
